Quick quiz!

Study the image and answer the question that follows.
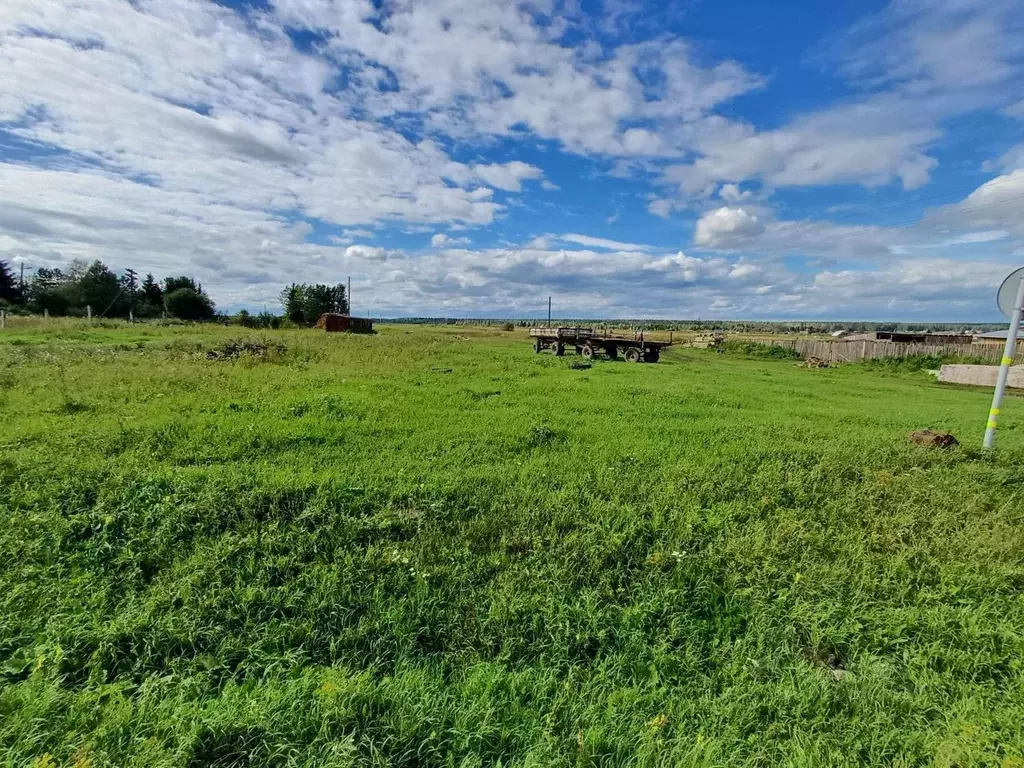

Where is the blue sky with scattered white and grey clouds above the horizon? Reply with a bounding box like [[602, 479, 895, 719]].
[[0, 0, 1024, 322]]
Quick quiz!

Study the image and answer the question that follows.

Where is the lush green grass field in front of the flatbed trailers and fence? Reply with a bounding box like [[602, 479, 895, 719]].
[[0, 322, 1024, 768]]
